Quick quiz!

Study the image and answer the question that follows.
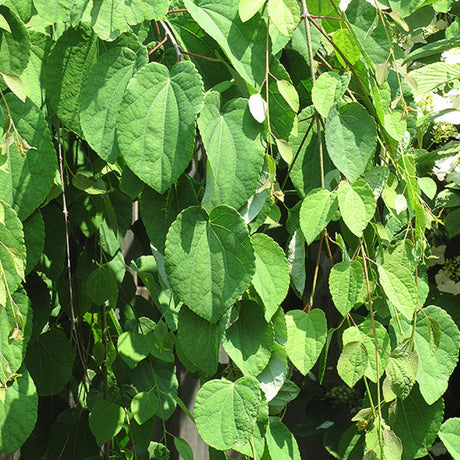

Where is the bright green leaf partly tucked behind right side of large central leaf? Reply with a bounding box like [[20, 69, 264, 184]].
[[251, 233, 289, 321]]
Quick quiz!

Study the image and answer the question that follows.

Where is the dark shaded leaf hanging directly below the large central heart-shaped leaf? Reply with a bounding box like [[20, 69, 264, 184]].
[[176, 305, 227, 376]]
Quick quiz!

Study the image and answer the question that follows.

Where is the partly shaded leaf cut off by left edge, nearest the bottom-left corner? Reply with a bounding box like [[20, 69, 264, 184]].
[[0, 369, 38, 455]]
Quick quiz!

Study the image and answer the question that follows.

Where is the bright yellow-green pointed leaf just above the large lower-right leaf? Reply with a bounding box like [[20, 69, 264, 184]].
[[378, 262, 418, 320]]
